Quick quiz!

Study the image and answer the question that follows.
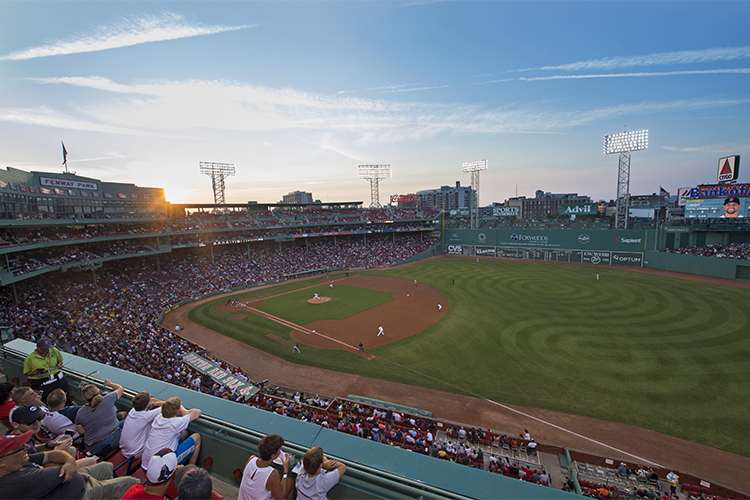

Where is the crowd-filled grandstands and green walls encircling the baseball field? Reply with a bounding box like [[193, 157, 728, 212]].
[[0, 170, 748, 499]]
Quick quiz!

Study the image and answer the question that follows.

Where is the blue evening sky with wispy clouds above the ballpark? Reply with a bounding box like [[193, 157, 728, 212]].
[[0, 0, 750, 206]]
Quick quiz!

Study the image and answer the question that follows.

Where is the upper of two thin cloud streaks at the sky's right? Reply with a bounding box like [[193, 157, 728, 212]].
[[511, 46, 750, 71]]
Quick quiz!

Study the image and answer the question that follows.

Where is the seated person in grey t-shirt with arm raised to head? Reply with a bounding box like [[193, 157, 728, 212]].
[[75, 380, 125, 456]]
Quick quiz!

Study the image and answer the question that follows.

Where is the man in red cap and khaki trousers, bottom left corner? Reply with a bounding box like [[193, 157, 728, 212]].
[[0, 431, 139, 500]]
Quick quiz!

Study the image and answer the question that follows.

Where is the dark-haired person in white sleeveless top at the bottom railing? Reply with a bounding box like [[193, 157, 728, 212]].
[[239, 434, 294, 500]]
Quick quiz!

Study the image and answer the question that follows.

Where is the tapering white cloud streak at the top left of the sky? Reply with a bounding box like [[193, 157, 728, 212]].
[[0, 12, 256, 61]]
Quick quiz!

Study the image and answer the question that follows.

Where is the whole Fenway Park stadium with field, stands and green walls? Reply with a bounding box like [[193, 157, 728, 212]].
[[0, 167, 750, 500]]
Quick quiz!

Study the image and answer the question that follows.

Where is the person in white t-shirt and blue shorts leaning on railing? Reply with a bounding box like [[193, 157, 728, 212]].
[[141, 397, 201, 471]]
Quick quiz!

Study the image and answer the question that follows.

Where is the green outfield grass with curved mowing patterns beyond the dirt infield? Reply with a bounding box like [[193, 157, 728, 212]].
[[191, 258, 750, 456]]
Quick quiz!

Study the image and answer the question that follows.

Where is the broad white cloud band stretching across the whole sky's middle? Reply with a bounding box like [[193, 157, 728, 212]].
[[10, 76, 750, 141]]
